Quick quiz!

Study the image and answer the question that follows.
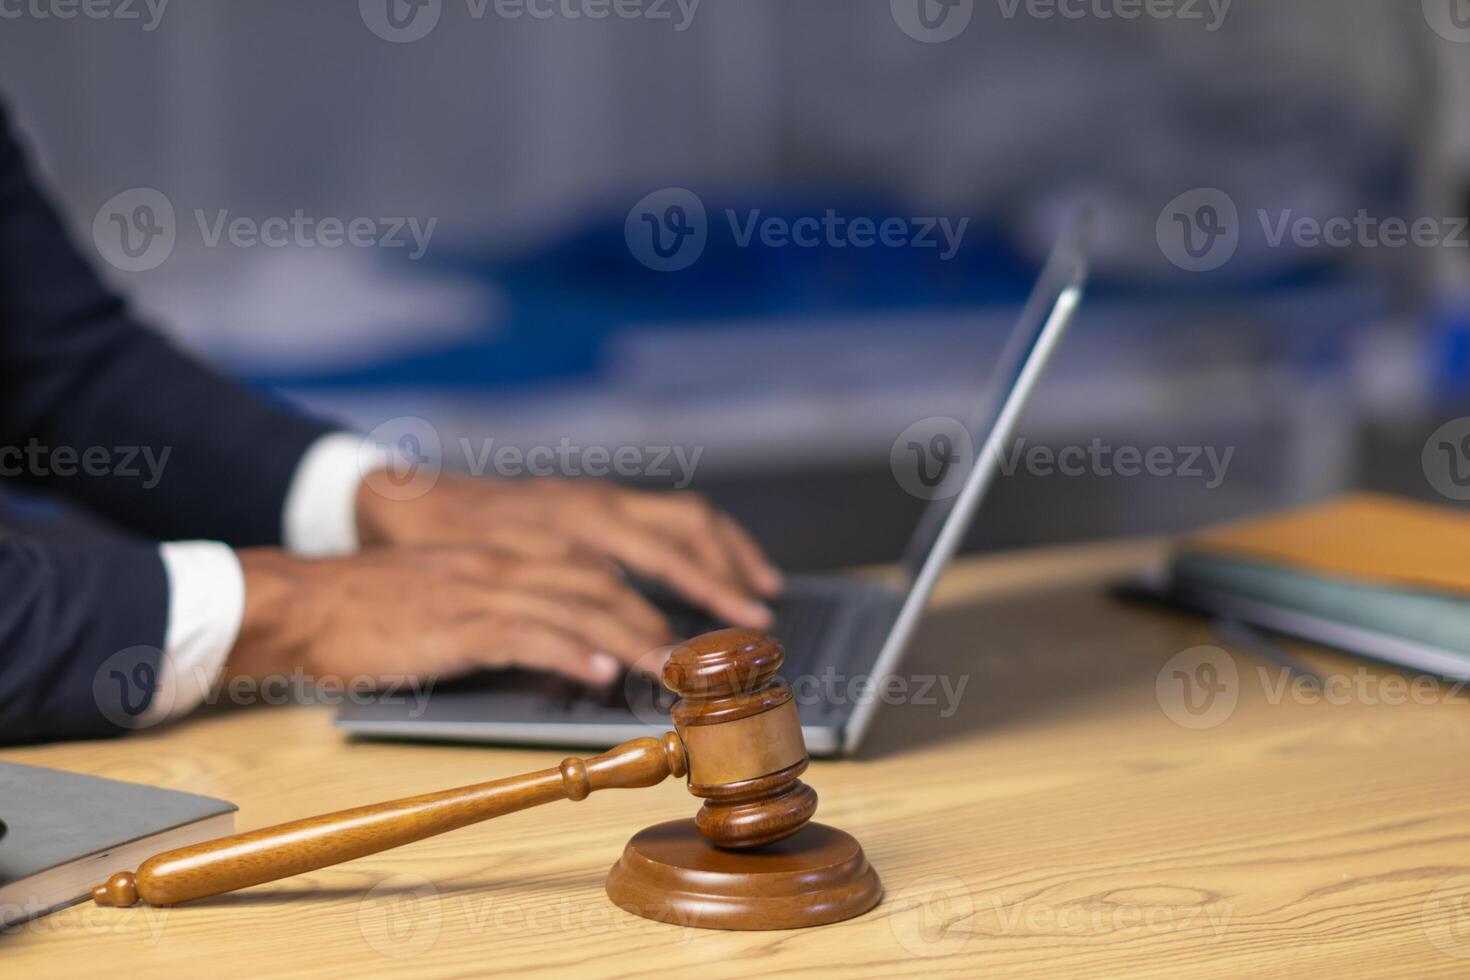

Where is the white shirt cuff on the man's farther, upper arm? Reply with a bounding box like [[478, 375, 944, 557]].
[[282, 432, 373, 558]]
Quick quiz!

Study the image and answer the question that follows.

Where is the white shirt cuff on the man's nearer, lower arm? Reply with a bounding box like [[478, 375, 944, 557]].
[[138, 541, 245, 726]]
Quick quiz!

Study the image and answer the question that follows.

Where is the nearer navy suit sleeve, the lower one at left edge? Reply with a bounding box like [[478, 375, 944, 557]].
[[0, 538, 168, 745]]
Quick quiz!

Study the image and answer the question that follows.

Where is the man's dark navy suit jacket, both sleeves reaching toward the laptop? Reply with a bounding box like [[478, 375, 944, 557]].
[[0, 99, 336, 743]]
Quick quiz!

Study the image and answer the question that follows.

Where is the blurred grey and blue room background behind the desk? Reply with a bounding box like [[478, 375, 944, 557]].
[[0, 0, 1470, 569]]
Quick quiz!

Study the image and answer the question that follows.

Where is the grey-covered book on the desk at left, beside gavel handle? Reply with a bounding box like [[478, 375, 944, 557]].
[[0, 763, 235, 927]]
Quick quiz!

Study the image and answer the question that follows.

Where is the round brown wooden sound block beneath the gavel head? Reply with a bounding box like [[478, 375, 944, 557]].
[[607, 820, 883, 929]]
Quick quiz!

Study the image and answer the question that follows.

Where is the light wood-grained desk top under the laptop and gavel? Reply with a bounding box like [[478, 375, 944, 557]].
[[0, 545, 1470, 979]]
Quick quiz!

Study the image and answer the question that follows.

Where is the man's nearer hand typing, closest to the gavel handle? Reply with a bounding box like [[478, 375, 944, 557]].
[[226, 547, 673, 685]]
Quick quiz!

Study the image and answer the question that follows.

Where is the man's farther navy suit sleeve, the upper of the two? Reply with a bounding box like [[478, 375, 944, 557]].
[[0, 97, 329, 543]]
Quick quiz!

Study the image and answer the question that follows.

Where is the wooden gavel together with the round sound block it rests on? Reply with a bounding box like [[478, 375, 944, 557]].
[[93, 629, 882, 929]]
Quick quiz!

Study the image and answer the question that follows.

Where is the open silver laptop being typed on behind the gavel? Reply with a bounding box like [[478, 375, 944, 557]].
[[337, 220, 1086, 757]]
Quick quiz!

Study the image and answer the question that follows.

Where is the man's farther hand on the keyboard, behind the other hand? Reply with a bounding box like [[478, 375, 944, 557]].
[[357, 476, 781, 627]]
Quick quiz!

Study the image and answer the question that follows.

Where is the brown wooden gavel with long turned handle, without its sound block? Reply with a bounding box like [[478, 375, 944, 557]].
[[93, 629, 823, 918]]
